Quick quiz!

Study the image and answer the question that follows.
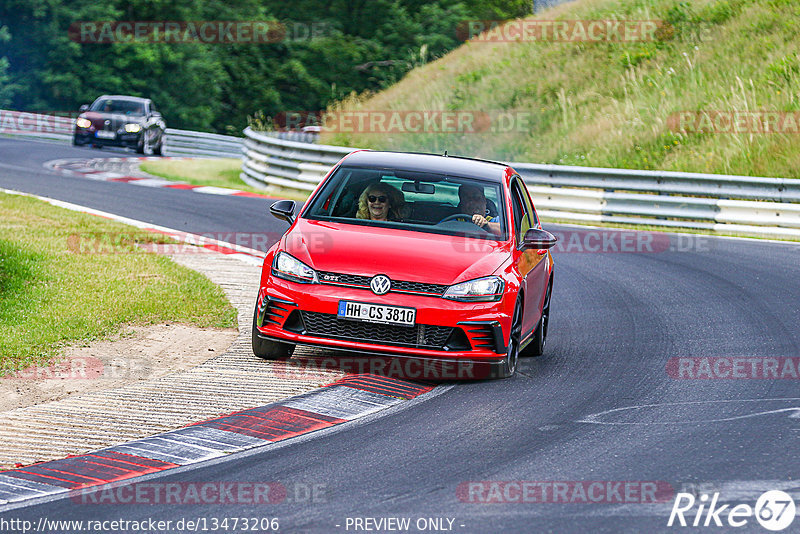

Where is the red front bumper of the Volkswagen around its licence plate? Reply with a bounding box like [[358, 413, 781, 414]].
[[256, 276, 513, 378]]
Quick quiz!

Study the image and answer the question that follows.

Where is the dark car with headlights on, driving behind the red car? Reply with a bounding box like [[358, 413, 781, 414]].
[[72, 95, 167, 156]]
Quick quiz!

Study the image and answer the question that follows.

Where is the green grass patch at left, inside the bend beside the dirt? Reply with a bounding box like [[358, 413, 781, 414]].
[[0, 194, 236, 374]]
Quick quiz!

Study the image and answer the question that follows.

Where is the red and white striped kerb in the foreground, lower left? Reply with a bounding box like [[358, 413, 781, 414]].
[[0, 375, 434, 504]]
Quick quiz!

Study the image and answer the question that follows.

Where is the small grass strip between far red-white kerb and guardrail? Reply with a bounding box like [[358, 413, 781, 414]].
[[140, 158, 308, 202]]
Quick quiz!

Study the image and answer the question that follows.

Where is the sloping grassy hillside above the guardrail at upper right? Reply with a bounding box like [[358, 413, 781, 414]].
[[322, 0, 800, 177]]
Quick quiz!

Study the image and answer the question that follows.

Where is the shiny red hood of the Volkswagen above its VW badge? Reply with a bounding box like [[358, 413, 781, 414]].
[[283, 219, 510, 285]]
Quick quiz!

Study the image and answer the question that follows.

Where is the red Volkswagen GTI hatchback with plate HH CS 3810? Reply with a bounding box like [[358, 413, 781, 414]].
[[253, 150, 556, 378]]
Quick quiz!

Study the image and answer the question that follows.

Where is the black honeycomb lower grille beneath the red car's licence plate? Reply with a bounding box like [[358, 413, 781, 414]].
[[302, 311, 453, 350]]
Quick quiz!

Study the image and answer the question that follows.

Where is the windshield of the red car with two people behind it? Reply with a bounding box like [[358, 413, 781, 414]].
[[303, 166, 507, 240]]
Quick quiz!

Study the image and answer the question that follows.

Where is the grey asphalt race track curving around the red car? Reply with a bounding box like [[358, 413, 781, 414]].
[[0, 140, 800, 533]]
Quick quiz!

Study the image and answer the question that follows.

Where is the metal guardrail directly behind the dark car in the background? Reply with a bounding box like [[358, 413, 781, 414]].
[[0, 110, 243, 158]]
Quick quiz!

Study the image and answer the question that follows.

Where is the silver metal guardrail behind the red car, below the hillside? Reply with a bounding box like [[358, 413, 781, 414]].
[[241, 128, 800, 237]]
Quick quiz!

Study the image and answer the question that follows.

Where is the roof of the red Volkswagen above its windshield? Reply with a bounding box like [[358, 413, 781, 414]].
[[342, 150, 508, 182]]
